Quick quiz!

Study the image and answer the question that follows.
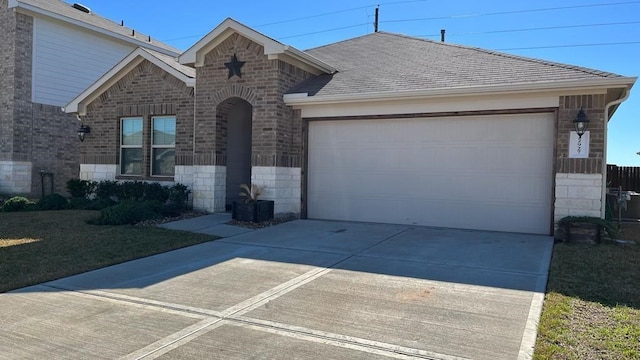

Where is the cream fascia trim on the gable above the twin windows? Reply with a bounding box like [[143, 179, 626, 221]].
[[62, 48, 196, 115]]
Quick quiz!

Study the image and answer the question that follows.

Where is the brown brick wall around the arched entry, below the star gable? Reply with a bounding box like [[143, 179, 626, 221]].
[[196, 33, 312, 167]]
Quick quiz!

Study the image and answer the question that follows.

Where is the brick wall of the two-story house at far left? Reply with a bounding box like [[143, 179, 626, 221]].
[[0, 0, 79, 194]]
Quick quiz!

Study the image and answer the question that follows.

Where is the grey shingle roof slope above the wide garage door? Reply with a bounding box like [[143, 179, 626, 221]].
[[296, 32, 620, 96]]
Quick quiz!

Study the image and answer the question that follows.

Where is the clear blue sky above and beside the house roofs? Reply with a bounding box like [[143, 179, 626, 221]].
[[69, 0, 640, 166]]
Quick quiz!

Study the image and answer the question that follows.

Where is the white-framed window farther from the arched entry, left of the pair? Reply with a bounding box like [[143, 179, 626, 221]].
[[120, 117, 143, 176]]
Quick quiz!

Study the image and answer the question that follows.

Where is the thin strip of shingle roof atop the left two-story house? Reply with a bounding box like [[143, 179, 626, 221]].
[[17, 0, 181, 54]]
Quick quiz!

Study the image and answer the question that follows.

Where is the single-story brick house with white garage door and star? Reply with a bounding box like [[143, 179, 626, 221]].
[[66, 19, 636, 234]]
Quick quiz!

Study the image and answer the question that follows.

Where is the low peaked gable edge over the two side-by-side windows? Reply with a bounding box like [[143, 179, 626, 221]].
[[63, 48, 196, 115]]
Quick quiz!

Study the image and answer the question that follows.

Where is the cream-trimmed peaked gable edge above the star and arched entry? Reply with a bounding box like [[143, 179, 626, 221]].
[[179, 18, 336, 75]]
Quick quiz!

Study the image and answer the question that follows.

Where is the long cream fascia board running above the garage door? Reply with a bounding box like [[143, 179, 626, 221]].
[[284, 77, 637, 106]]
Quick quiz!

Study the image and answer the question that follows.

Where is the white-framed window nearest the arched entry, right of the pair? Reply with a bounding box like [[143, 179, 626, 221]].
[[151, 116, 176, 176]]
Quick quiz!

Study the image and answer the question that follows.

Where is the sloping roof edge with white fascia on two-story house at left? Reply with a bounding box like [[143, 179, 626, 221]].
[[9, 0, 180, 56]]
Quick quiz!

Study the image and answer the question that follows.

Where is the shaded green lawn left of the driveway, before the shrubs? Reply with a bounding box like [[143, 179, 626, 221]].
[[0, 210, 216, 292]]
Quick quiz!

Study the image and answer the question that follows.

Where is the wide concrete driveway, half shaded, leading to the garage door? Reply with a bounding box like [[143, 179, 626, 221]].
[[0, 220, 553, 360]]
